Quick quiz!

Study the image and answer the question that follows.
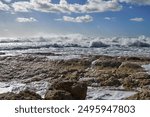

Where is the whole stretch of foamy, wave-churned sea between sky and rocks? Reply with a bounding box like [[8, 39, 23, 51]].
[[0, 34, 150, 59]]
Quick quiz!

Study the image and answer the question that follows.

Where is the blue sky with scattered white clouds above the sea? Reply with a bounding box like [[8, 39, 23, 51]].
[[0, 0, 150, 37]]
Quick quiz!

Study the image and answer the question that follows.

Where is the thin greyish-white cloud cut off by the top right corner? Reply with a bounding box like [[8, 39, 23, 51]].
[[119, 0, 150, 5]]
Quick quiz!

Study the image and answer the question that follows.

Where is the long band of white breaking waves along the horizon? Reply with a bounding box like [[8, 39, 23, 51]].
[[0, 35, 150, 50]]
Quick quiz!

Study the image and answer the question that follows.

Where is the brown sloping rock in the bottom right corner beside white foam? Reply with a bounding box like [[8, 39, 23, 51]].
[[127, 90, 150, 100]]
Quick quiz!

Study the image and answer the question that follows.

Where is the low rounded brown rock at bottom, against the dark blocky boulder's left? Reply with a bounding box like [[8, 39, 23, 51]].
[[45, 90, 73, 100]]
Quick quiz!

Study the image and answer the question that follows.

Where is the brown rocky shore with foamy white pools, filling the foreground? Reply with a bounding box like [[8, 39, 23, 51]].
[[0, 54, 150, 100]]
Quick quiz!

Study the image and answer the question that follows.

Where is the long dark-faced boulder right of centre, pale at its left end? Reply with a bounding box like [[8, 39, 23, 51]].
[[92, 59, 121, 68]]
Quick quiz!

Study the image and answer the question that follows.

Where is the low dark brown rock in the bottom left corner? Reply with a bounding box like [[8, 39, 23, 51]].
[[0, 90, 42, 100]]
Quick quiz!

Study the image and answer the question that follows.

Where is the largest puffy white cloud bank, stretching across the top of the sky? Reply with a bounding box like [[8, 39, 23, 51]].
[[12, 0, 122, 13]]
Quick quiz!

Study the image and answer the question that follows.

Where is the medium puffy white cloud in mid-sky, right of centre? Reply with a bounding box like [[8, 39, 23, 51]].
[[63, 15, 93, 23]]
